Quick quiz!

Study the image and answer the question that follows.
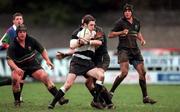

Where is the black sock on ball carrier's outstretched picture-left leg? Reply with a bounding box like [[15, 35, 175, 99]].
[[51, 89, 64, 106]]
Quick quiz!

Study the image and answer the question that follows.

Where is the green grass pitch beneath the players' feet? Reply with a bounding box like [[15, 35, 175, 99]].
[[0, 83, 180, 112]]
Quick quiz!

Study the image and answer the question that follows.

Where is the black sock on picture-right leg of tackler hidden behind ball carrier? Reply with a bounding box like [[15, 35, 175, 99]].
[[100, 87, 112, 104]]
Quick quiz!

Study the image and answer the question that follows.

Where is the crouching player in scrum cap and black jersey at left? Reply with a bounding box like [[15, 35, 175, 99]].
[[7, 24, 68, 106]]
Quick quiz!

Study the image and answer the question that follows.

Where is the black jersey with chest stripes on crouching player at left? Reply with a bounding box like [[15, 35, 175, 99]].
[[7, 35, 45, 68]]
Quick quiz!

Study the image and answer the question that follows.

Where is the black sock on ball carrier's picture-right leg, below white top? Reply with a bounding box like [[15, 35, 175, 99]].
[[94, 83, 102, 102]]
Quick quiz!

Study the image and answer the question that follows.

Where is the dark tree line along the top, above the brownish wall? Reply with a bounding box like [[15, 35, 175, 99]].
[[0, 0, 180, 24]]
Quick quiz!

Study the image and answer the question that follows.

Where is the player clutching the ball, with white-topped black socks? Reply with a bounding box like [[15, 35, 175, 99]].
[[48, 14, 111, 109]]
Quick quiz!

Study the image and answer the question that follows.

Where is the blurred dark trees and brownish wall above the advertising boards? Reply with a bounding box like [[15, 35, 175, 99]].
[[0, 0, 180, 49]]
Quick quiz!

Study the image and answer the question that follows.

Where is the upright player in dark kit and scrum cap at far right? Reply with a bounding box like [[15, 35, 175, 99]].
[[109, 4, 156, 104]]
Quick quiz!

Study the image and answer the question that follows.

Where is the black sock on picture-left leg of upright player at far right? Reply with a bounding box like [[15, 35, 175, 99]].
[[110, 75, 126, 93]]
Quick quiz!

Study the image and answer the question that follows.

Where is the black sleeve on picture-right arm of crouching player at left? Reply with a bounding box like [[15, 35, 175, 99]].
[[29, 37, 45, 53]]
